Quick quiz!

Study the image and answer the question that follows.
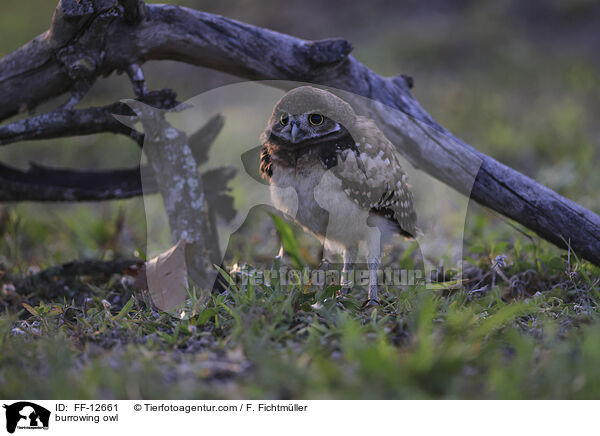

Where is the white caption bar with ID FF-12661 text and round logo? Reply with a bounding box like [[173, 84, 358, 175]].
[[0, 400, 599, 436]]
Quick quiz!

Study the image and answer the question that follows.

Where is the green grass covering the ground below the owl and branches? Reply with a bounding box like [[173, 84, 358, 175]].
[[0, 225, 600, 399]]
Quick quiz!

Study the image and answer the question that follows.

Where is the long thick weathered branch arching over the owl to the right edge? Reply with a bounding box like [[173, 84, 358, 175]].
[[0, 0, 600, 265]]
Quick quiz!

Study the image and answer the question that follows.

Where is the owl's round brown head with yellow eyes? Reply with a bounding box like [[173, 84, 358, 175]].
[[263, 86, 356, 148]]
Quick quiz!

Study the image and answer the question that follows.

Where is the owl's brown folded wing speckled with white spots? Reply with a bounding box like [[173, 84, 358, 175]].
[[331, 116, 420, 237]]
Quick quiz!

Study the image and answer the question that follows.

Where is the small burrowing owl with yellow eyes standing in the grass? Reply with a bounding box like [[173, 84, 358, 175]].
[[260, 86, 419, 304]]
